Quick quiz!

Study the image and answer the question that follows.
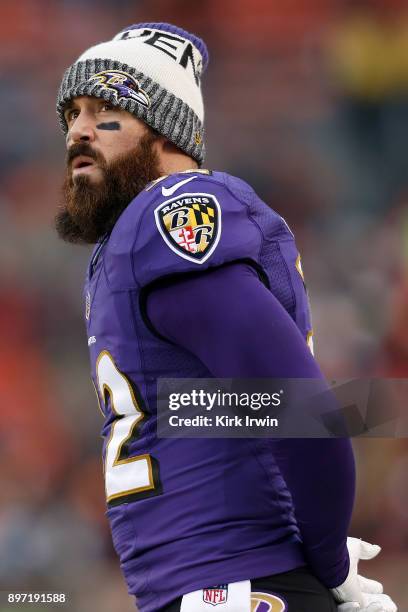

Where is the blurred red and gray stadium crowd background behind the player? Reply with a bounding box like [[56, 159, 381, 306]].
[[0, 0, 408, 612]]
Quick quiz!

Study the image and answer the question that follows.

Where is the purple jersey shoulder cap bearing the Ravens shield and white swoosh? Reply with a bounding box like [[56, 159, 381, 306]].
[[105, 170, 290, 288]]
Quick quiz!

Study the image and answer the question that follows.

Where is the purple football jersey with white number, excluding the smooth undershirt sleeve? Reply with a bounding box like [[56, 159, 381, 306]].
[[85, 171, 311, 612]]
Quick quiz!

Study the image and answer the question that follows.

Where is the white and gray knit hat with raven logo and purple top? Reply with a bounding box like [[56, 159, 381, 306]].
[[57, 23, 208, 166]]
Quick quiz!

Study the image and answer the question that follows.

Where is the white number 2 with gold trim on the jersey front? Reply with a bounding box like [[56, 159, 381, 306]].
[[96, 351, 161, 507]]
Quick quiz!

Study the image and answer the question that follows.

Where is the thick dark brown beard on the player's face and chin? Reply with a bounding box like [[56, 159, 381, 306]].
[[55, 132, 162, 244]]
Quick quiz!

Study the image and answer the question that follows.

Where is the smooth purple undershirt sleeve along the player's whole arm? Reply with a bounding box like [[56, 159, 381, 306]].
[[147, 263, 355, 587]]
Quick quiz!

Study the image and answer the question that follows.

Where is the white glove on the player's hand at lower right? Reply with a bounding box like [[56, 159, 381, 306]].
[[330, 538, 397, 612]]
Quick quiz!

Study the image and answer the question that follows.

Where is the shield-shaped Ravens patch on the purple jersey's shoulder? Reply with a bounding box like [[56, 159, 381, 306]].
[[154, 193, 221, 264]]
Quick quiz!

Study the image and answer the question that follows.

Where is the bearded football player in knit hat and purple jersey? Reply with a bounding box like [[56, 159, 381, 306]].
[[56, 23, 396, 612]]
